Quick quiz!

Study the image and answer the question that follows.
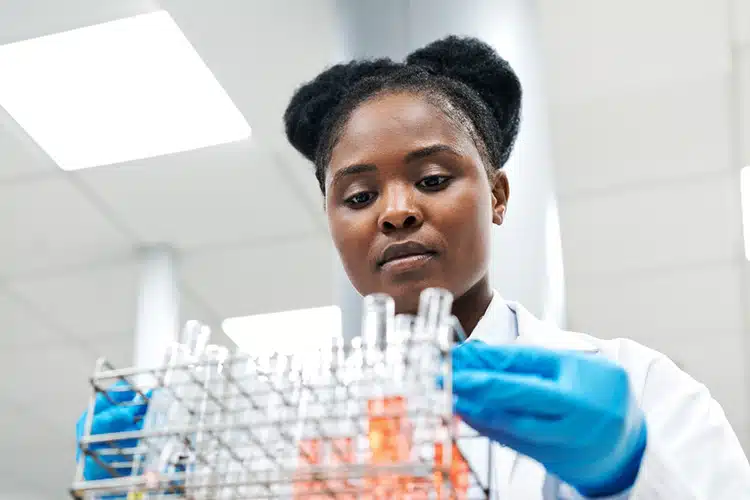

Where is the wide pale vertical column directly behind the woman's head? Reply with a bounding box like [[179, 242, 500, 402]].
[[334, 0, 565, 337]]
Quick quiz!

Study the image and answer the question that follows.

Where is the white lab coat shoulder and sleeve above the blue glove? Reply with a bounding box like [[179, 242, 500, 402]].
[[511, 305, 750, 500]]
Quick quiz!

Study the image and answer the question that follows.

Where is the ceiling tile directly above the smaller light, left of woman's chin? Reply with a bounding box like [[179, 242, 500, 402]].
[[182, 237, 333, 318]]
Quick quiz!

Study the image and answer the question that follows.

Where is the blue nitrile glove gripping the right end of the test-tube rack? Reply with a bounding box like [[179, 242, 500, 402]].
[[453, 342, 646, 497]]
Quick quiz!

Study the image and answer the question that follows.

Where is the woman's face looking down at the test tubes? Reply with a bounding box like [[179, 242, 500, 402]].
[[326, 92, 508, 312]]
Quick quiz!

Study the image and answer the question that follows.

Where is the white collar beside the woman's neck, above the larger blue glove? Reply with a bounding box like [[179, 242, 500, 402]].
[[469, 291, 599, 353]]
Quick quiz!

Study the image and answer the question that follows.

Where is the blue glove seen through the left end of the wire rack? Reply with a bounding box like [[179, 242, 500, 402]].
[[76, 382, 150, 480]]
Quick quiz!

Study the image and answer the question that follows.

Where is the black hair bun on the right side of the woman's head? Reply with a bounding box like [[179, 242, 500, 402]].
[[406, 35, 522, 160]]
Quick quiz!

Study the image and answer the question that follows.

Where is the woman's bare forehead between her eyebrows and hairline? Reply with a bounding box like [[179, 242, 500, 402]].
[[331, 93, 472, 166]]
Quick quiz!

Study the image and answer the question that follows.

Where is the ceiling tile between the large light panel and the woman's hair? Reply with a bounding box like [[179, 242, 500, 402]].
[[161, 0, 342, 141]]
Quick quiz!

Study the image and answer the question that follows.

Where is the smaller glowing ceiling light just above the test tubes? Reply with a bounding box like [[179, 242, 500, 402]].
[[221, 306, 341, 354]]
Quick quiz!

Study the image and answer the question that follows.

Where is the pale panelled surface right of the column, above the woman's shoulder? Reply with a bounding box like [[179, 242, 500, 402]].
[[540, 0, 750, 448]]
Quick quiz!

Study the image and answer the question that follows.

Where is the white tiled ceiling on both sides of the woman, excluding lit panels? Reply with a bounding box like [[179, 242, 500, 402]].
[[0, 0, 750, 500]]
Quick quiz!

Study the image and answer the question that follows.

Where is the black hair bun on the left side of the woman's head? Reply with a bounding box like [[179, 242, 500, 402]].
[[284, 59, 397, 161]]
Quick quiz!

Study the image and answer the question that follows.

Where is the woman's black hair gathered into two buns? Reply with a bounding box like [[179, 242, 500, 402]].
[[284, 36, 522, 193]]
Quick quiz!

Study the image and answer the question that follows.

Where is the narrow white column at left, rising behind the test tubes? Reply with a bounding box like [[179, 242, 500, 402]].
[[134, 246, 180, 368]]
